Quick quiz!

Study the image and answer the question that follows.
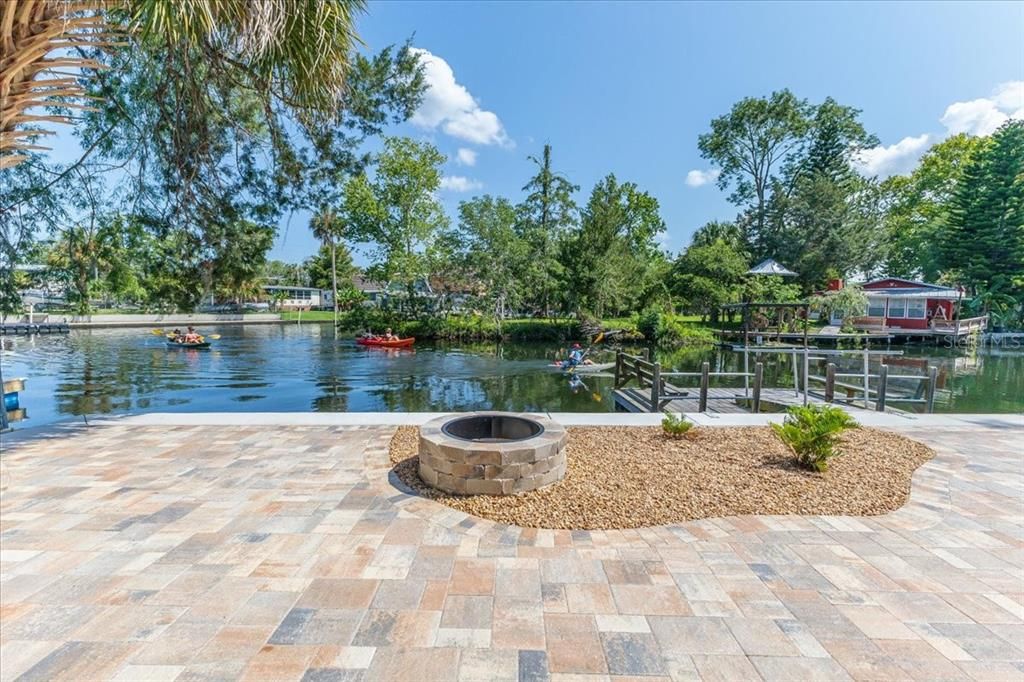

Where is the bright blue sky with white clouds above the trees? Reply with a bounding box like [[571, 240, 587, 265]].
[[49, 1, 1024, 261]]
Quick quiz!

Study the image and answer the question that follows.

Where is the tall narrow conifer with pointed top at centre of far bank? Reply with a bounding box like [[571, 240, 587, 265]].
[[519, 144, 580, 316]]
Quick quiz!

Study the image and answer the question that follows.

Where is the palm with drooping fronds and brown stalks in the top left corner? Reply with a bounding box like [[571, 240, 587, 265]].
[[0, 0, 366, 168]]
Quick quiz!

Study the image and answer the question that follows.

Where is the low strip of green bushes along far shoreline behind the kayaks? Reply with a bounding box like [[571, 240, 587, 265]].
[[321, 310, 715, 348]]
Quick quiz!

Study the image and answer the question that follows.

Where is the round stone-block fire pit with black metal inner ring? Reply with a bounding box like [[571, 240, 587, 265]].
[[420, 412, 568, 495]]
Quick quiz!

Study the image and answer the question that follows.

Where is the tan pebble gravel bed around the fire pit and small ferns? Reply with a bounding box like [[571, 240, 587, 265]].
[[390, 427, 934, 529]]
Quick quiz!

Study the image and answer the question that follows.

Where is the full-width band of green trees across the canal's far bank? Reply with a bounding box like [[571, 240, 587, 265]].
[[0, 41, 1024, 322]]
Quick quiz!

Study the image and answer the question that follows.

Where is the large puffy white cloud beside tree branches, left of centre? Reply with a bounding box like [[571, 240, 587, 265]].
[[412, 47, 513, 146]]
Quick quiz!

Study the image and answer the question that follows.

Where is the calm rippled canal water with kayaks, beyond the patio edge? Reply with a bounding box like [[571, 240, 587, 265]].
[[2, 325, 1024, 426]]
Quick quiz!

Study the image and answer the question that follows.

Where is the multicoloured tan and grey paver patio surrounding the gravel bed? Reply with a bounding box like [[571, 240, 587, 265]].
[[0, 424, 1024, 682]]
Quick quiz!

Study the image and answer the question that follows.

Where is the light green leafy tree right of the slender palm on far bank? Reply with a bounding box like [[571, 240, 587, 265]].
[[344, 137, 447, 307]]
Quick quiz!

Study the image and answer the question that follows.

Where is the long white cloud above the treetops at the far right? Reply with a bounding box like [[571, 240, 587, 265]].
[[856, 81, 1024, 177]]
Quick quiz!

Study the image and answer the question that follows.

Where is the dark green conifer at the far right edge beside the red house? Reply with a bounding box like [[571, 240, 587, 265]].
[[942, 120, 1024, 309]]
